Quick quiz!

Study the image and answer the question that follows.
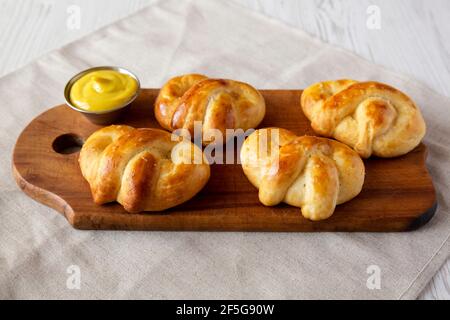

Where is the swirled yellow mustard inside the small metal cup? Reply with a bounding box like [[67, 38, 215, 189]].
[[70, 70, 138, 112]]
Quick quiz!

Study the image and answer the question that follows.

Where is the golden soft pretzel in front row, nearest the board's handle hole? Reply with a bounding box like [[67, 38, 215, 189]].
[[79, 125, 210, 212]]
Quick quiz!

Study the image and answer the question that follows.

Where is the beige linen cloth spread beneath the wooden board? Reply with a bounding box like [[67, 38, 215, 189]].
[[0, 0, 450, 299]]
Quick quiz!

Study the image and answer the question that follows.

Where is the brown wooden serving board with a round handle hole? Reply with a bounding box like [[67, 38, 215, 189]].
[[13, 89, 436, 231]]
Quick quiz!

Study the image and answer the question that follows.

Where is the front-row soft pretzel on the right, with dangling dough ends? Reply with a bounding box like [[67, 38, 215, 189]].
[[241, 128, 364, 221]]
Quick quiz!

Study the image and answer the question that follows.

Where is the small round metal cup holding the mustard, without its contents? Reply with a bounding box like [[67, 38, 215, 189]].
[[64, 66, 141, 125]]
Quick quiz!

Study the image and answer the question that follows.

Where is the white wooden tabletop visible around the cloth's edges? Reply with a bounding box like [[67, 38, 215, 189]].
[[0, 0, 450, 299]]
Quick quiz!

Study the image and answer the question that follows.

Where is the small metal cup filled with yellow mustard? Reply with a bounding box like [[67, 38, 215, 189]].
[[64, 66, 140, 125]]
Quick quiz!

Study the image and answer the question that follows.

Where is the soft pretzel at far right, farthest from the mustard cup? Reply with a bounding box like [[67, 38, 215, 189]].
[[301, 80, 426, 158]]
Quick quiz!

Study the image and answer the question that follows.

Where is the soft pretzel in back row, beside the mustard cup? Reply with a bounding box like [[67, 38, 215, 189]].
[[155, 74, 266, 145]]
